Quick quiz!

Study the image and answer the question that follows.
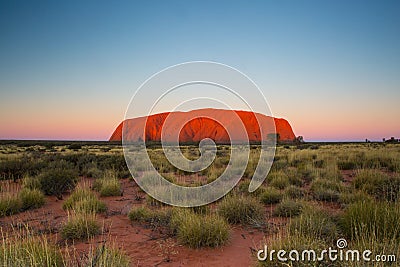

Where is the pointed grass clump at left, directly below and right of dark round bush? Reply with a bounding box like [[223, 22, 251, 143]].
[[63, 187, 107, 213]]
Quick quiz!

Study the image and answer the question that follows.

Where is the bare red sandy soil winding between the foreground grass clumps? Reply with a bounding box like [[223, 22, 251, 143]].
[[0, 179, 268, 266]]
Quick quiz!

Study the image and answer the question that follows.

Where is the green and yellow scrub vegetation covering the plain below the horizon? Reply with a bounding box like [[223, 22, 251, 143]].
[[0, 143, 400, 266]]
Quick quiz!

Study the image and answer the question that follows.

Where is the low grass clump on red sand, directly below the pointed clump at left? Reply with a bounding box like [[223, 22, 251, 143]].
[[61, 213, 100, 240]]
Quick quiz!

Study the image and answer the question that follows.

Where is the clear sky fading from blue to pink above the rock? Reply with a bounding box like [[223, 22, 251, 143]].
[[0, 0, 400, 141]]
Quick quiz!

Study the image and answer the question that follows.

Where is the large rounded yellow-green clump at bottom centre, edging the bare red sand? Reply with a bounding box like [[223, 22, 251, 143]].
[[175, 212, 229, 248]]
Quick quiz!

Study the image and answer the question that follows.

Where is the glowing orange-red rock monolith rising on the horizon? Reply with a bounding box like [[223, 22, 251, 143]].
[[110, 109, 296, 143]]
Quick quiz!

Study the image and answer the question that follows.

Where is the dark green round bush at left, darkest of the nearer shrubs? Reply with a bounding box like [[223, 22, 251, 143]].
[[39, 161, 78, 199]]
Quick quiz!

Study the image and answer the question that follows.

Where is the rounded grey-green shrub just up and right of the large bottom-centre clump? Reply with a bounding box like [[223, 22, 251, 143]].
[[217, 196, 265, 224]]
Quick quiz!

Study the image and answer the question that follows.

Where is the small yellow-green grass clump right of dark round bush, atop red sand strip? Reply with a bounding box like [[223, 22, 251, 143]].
[[93, 170, 122, 197]]
